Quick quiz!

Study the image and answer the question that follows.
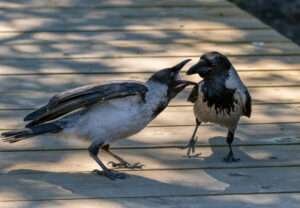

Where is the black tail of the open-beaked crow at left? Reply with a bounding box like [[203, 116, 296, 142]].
[[1, 123, 62, 143]]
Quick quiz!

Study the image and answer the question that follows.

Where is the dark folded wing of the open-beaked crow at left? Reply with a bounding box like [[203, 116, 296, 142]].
[[24, 81, 148, 127]]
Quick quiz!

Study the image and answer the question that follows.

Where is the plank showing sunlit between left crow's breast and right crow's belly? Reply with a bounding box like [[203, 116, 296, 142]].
[[0, 104, 300, 129]]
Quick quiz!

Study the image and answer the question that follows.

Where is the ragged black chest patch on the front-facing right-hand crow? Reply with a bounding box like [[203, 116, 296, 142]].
[[201, 74, 237, 114]]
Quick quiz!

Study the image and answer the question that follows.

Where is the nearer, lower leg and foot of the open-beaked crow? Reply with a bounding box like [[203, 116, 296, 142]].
[[88, 143, 126, 180]]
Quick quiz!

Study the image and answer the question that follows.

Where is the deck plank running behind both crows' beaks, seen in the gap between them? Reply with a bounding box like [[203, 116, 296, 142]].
[[0, 70, 300, 95]]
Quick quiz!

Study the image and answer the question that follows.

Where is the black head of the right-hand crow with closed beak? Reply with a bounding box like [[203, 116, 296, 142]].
[[187, 51, 231, 79]]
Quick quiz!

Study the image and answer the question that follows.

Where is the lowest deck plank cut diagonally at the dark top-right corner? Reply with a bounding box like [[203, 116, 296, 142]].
[[0, 28, 290, 44]]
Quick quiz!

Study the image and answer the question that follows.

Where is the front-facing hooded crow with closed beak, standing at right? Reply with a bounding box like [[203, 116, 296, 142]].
[[186, 52, 251, 162]]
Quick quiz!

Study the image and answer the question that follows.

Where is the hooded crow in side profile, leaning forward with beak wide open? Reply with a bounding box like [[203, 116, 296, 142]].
[[2, 59, 194, 179]]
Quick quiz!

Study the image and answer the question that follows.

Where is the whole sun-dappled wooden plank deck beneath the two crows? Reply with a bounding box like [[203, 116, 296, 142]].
[[0, 0, 300, 208]]
